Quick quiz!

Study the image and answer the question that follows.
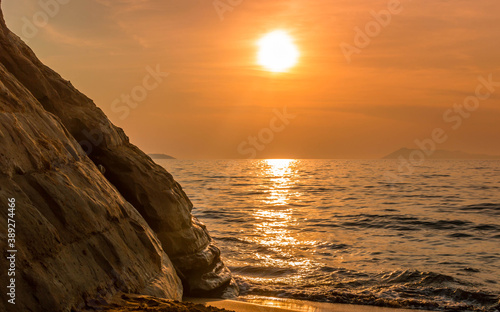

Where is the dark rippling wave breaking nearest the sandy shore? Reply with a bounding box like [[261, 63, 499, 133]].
[[236, 268, 500, 312]]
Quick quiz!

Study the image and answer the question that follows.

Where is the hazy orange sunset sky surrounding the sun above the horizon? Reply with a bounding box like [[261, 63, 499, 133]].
[[2, 0, 500, 158]]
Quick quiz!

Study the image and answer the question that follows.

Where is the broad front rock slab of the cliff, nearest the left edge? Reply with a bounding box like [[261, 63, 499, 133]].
[[0, 60, 182, 311]]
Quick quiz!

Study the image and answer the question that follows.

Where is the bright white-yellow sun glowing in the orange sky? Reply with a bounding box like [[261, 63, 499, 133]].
[[257, 30, 300, 73]]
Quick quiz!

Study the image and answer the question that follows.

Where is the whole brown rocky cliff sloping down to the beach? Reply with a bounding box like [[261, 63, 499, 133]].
[[0, 3, 237, 311]]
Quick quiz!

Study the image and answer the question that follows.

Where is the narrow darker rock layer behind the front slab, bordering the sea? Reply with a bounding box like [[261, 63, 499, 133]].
[[0, 0, 237, 304]]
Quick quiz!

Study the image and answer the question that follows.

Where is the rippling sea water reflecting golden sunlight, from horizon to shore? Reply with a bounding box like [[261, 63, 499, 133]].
[[157, 160, 500, 311]]
